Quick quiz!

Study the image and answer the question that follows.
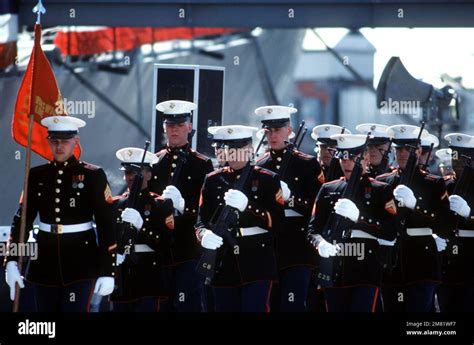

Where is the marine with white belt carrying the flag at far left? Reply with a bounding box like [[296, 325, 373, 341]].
[[6, 116, 117, 312]]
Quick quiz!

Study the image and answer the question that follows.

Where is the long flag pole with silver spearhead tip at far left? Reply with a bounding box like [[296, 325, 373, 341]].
[[13, 0, 46, 313]]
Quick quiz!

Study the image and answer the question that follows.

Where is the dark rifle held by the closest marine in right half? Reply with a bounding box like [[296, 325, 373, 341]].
[[318, 133, 370, 288]]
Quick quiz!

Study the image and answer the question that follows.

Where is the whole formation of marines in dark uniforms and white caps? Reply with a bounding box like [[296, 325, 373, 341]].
[[5, 100, 474, 312]]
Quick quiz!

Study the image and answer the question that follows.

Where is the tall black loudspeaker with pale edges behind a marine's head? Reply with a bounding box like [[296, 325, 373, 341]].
[[151, 64, 225, 156]]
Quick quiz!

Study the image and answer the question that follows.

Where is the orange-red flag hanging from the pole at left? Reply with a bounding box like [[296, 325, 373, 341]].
[[12, 24, 81, 160]]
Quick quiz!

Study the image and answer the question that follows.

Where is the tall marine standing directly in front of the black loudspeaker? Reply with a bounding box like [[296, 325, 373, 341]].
[[149, 100, 214, 312]]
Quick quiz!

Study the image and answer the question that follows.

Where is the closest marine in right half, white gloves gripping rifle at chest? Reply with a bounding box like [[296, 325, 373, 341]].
[[308, 134, 396, 312]]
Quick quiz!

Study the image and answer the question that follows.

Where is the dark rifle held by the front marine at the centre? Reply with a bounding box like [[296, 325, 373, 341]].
[[197, 161, 253, 285]]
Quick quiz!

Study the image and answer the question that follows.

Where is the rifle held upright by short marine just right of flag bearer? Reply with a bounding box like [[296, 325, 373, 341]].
[[117, 140, 150, 296]]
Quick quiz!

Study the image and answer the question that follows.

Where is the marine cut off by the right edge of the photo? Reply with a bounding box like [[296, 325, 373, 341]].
[[437, 133, 474, 312]]
